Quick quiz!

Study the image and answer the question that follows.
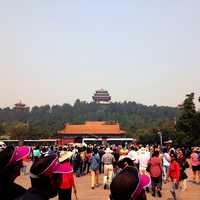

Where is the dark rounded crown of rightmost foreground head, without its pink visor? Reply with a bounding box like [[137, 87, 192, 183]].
[[110, 167, 139, 200]]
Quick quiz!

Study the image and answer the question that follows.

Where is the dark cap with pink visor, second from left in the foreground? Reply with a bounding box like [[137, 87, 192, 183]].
[[30, 155, 73, 178]]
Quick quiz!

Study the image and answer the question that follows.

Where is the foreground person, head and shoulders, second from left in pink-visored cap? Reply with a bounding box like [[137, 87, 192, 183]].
[[17, 155, 72, 200]]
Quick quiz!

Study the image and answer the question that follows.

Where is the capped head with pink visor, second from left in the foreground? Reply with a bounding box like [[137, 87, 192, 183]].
[[30, 155, 73, 198]]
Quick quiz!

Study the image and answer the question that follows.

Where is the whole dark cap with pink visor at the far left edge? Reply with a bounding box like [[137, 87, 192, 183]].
[[0, 146, 31, 169]]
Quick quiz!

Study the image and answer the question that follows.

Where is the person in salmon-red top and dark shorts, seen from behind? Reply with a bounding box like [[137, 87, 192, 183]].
[[148, 151, 163, 197]]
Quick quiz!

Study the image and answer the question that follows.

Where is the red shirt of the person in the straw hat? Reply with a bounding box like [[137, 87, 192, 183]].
[[60, 163, 74, 190]]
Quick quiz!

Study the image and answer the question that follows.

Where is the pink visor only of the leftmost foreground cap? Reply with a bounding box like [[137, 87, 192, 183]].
[[9, 146, 31, 164]]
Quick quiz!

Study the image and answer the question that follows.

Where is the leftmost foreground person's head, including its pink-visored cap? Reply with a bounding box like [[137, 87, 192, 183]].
[[0, 146, 30, 182]]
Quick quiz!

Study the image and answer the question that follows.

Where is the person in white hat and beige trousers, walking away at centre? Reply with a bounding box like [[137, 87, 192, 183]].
[[101, 148, 115, 189]]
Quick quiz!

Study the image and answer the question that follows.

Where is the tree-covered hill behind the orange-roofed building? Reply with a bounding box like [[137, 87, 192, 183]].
[[0, 100, 179, 140]]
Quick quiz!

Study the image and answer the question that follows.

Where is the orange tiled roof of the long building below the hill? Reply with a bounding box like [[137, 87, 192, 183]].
[[57, 121, 126, 136]]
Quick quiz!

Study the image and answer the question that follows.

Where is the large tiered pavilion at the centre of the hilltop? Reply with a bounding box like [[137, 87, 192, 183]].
[[92, 89, 111, 103]]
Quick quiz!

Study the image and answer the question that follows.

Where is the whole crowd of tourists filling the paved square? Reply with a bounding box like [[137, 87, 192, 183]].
[[0, 141, 200, 200]]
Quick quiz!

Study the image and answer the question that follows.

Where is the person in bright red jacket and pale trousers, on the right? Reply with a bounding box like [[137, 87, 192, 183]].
[[168, 152, 180, 200]]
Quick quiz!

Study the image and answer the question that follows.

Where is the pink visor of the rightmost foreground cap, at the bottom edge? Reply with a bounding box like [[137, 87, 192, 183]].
[[131, 175, 151, 200]]
